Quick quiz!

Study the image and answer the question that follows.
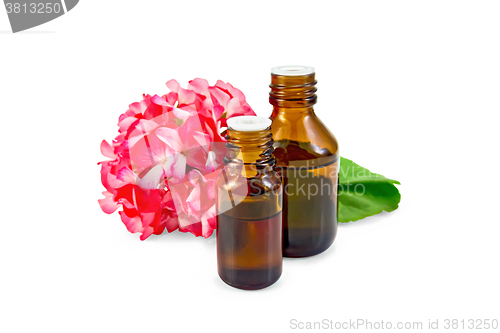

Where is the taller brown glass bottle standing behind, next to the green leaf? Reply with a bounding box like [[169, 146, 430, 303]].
[[269, 66, 339, 257]]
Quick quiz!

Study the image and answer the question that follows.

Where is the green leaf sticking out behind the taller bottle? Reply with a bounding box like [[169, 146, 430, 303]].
[[338, 157, 401, 222]]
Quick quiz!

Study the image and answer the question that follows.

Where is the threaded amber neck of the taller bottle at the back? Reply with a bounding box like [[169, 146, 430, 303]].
[[269, 69, 318, 108]]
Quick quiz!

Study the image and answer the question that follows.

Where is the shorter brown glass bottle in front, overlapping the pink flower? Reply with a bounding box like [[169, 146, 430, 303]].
[[216, 116, 283, 290]]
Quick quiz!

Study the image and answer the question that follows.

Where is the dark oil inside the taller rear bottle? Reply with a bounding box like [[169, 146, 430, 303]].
[[274, 140, 338, 257]]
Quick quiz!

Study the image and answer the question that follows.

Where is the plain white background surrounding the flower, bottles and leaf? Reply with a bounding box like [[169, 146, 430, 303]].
[[0, 0, 500, 333]]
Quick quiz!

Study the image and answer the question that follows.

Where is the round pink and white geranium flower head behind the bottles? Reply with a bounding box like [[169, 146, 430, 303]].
[[98, 78, 255, 240]]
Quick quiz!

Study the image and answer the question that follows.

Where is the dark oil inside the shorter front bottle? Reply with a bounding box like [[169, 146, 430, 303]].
[[217, 210, 283, 290]]
